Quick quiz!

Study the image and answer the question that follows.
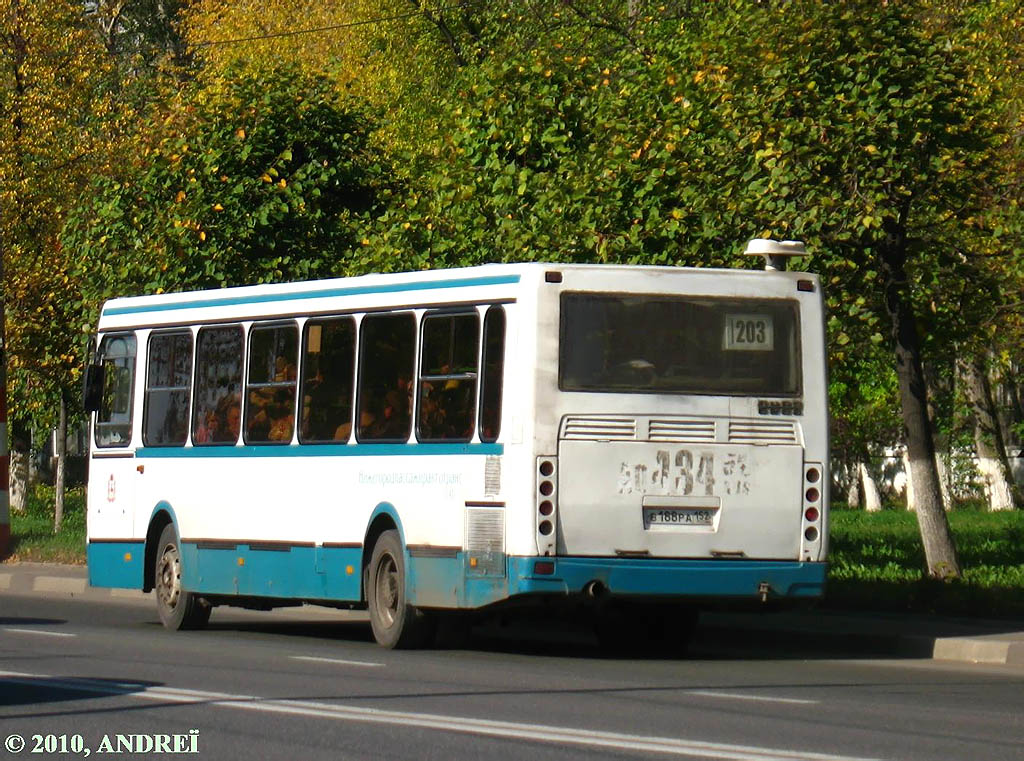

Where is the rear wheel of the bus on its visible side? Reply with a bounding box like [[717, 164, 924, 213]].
[[367, 530, 433, 648]]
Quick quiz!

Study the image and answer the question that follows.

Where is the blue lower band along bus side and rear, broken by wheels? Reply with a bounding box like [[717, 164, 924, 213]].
[[87, 541, 827, 608]]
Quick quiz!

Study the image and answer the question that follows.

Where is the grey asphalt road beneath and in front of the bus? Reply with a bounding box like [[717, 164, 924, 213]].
[[0, 597, 1024, 761]]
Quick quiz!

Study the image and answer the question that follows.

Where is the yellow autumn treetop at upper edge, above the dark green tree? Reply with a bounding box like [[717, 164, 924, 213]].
[[183, 0, 491, 146]]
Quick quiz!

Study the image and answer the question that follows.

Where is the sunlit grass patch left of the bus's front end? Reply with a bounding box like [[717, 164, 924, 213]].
[[10, 484, 85, 564]]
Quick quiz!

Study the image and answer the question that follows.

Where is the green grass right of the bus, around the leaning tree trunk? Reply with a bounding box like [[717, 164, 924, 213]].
[[825, 509, 1024, 617]]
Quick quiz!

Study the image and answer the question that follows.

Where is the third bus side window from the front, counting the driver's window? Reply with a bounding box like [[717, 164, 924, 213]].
[[193, 325, 245, 445]]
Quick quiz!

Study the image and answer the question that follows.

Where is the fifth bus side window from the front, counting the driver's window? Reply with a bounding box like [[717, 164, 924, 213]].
[[299, 318, 355, 443]]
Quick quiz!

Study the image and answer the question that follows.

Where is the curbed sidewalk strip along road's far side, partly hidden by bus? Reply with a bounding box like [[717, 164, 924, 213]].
[[6, 563, 1024, 667]]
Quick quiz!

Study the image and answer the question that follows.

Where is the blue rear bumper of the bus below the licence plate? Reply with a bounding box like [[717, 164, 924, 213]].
[[509, 557, 827, 601]]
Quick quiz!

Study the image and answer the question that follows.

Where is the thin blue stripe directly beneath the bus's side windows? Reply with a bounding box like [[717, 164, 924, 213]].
[[135, 443, 505, 459]]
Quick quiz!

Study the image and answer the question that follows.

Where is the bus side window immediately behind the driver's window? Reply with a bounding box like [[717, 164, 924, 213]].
[[142, 332, 191, 447]]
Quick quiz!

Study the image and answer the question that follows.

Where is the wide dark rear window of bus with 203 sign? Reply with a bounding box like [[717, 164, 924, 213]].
[[558, 293, 801, 396]]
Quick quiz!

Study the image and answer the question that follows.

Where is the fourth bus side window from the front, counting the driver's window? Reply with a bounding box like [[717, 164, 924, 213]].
[[245, 325, 299, 443]]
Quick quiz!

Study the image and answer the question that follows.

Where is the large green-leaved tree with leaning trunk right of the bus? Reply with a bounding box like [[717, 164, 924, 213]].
[[364, 0, 1019, 577]]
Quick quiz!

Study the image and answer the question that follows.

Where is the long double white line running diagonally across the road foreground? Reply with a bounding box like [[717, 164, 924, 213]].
[[0, 671, 869, 761]]
